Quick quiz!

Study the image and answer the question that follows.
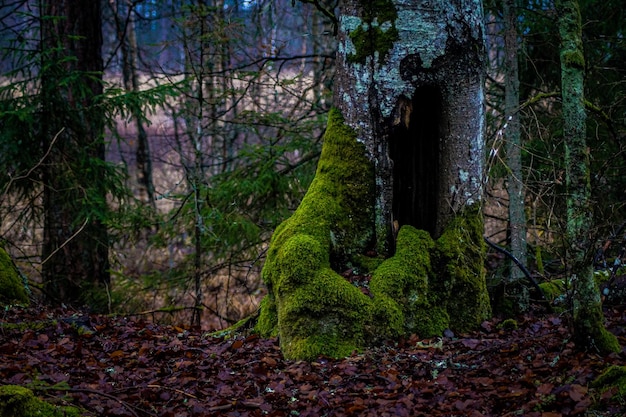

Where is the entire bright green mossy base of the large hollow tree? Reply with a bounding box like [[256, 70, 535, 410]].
[[256, 110, 490, 360]]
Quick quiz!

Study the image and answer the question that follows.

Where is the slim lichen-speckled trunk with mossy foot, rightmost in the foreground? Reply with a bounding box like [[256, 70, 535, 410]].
[[556, 0, 621, 353]]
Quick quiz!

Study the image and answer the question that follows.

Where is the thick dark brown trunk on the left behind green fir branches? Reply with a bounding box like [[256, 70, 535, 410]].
[[41, 0, 110, 309]]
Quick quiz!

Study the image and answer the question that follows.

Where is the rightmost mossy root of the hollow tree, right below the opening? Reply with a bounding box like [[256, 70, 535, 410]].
[[435, 205, 491, 332]]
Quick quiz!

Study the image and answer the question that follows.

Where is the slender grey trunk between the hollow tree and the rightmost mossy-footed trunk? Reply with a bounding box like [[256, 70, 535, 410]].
[[502, 0, 528, 311]]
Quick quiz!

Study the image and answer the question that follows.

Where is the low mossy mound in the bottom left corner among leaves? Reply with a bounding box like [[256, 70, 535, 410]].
[[0, 385, 81, 417]]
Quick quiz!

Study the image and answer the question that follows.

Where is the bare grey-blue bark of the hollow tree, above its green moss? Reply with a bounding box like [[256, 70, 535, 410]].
[[334, 0, 484, 249]]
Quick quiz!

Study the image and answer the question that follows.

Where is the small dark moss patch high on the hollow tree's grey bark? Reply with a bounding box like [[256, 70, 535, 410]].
[[348, 0, 398, 64]]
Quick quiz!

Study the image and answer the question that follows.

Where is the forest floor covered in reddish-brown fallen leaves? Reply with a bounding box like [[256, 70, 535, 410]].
[[0, 307, 626, 417]]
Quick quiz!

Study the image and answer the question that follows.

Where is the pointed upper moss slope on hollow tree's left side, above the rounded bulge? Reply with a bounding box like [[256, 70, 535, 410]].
[[260, 109, 375, 268]]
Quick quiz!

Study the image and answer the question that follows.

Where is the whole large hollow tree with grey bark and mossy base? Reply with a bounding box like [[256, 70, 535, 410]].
[[257, 0, 490, 359]]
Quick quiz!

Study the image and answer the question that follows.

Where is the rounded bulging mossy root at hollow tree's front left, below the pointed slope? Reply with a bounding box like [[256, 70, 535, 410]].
[[257, 234, 371, 360]]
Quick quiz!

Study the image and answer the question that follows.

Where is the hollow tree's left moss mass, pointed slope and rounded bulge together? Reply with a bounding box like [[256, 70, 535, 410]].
[[256, 109, 375, 359]]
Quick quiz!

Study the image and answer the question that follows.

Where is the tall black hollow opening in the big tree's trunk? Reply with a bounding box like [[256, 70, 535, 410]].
[[389, 86, 442, 236]]
